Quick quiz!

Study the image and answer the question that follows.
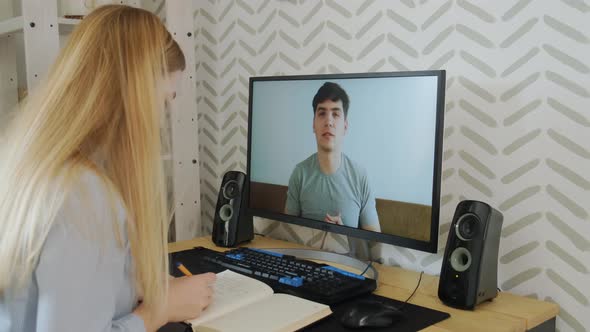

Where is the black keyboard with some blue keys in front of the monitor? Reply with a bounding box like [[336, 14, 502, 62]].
[[173, 247, 377, 304]]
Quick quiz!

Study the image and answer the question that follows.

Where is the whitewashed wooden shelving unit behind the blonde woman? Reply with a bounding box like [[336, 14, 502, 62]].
[[0, 0, 202, 240]]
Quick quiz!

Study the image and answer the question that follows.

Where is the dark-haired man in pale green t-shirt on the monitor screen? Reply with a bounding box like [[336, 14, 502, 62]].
[[285, 82, 381, 232]]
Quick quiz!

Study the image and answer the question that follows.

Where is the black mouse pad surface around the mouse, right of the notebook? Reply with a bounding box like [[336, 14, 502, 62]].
[[301, 294, 451, 332]]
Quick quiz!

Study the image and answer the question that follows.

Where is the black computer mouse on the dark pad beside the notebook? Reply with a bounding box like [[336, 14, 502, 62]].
[[339, 301, 405, 329]]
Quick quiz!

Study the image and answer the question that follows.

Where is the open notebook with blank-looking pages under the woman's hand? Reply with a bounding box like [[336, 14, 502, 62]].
[[189, 270, 332, 332]]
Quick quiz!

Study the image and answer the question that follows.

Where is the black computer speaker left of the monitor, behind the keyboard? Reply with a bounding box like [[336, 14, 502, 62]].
[[211, 171, 254, 247]]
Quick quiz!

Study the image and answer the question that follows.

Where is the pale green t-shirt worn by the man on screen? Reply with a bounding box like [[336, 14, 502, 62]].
[[285, 153, 379, 228]]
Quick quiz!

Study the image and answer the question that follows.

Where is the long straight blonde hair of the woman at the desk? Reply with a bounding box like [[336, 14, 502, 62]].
[[0, 5, 185, 308]]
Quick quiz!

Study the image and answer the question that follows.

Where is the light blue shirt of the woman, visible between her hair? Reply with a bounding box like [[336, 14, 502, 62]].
[[33, 173, 145, 332]]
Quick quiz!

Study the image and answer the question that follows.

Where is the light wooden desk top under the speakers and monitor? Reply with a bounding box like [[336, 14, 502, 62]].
[[168, 236, 559, 332]]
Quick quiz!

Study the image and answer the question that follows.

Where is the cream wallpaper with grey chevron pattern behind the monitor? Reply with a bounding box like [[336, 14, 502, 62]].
[[150, 0, 590, 331]]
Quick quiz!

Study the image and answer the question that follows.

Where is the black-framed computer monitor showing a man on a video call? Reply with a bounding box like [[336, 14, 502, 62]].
[[245, 70, 445, 252]]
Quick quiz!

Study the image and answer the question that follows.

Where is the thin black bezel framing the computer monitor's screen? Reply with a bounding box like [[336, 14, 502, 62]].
[[247, 70, 446, 253]]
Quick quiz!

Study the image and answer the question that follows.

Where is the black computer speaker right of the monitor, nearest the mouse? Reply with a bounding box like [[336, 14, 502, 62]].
[[438, 201, 503, 310]]
